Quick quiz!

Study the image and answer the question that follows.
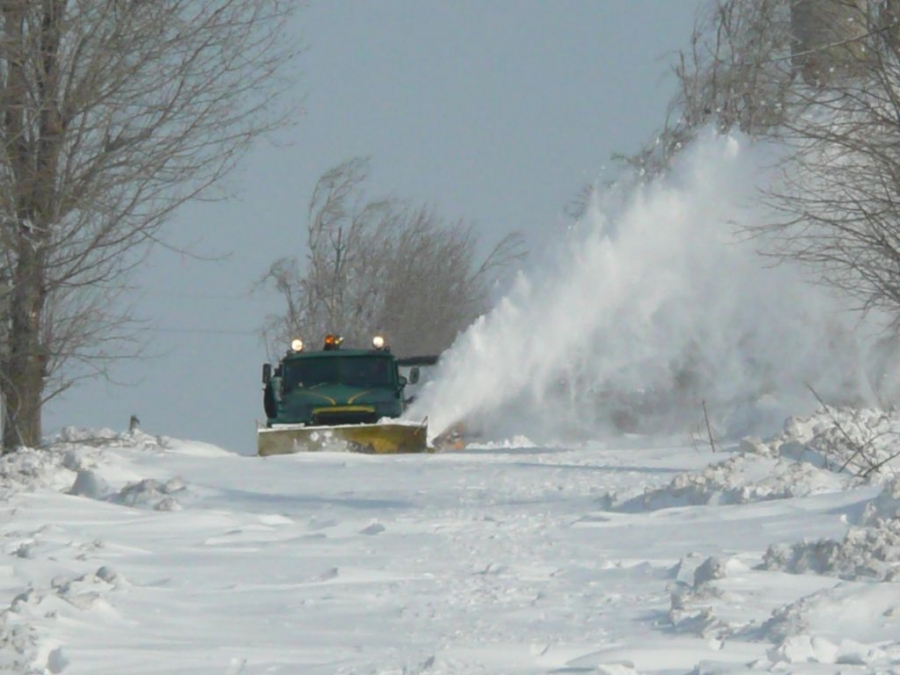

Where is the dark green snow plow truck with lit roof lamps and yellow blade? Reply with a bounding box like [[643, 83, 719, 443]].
[[257, 335, 427, 456]]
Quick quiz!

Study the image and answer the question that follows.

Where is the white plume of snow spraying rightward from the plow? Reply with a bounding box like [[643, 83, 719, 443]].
[[408, 135, 892, 442]]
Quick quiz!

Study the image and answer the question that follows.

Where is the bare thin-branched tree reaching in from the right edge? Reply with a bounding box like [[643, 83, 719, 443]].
[[756, 0, 900, 326]]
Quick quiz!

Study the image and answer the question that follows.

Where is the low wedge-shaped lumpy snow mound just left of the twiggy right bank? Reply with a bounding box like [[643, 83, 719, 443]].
[[609, 453, 846, 512]]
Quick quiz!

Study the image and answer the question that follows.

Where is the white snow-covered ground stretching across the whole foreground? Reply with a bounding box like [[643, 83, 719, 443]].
[[0, 411, 900, 675]]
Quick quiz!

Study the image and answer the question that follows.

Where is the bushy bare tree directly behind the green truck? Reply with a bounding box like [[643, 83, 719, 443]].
[[262, 158, 523, 354]]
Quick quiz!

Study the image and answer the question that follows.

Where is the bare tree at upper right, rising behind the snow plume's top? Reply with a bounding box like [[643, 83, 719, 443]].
[[632, 0, 900, 168]]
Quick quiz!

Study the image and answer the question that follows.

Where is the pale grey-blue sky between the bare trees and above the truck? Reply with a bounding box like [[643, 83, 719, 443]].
[[45, 0, 702, 454]]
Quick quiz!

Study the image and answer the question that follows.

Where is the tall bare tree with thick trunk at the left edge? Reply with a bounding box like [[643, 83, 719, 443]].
[[0, 0, 298, 449]]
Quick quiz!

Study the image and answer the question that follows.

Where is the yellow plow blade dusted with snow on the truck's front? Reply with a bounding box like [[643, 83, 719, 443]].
[[256, 423, 427, 457]]
